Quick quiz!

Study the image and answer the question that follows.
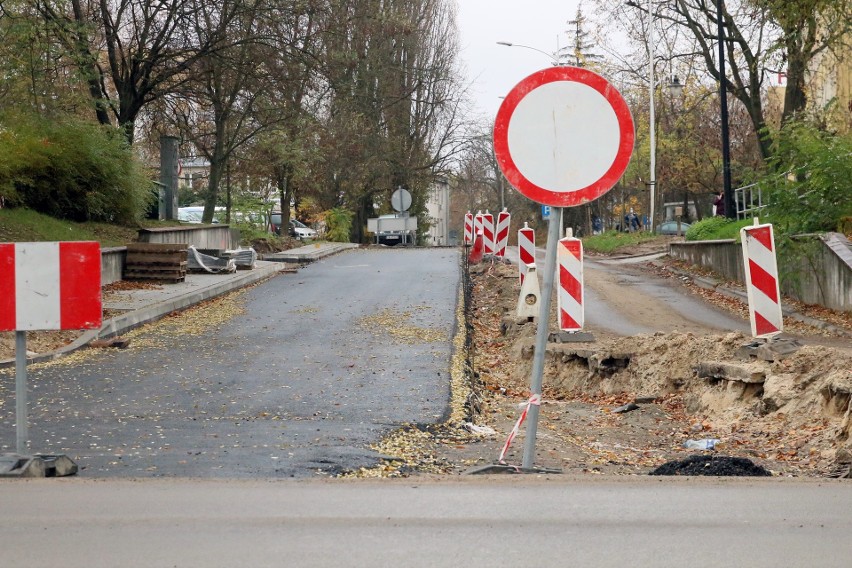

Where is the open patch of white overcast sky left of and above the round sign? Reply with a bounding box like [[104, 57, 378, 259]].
[[457, 0, 588, 120]]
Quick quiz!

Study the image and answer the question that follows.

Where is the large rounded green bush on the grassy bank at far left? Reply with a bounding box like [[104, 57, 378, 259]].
[[0, 111, 154, 224]]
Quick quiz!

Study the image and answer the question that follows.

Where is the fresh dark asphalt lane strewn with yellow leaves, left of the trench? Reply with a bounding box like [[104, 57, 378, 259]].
[[0, 248, 460, 478]]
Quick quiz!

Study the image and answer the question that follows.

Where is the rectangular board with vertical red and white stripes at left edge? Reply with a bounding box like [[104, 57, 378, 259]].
[[0, 242, 103, 331]]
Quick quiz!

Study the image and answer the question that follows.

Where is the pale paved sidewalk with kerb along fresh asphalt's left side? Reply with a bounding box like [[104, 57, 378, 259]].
[[0, 243, 358, 368]]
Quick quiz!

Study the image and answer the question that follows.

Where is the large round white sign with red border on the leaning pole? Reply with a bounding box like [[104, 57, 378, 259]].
[[494, 66, 635, 207]]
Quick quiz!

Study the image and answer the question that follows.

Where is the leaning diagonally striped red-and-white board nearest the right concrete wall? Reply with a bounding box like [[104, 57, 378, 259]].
[[740, 219, 784, 337]]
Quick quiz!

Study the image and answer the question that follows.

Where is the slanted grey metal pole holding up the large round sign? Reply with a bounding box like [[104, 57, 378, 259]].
[[521, 207, 562, 469]]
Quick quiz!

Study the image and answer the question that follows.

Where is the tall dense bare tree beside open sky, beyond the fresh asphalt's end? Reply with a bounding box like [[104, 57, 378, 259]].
[[318, 0, 461, 239]]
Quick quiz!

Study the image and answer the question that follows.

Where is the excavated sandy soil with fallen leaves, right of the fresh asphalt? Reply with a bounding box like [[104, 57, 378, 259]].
[[433, 264, 852, 477]]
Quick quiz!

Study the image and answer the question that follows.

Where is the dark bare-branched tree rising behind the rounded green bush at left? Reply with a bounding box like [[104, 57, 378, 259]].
[[31, 0, 235, 143]]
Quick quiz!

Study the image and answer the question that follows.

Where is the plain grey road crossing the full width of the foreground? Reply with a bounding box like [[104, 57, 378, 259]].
[[0, 476, 852, 568]]
